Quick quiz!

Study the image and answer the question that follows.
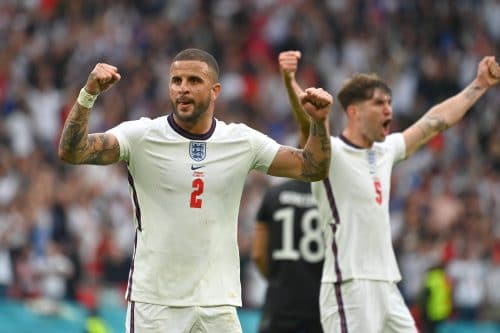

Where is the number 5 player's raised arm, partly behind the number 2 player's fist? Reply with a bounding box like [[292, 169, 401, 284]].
[[278, 51, 311, 147]]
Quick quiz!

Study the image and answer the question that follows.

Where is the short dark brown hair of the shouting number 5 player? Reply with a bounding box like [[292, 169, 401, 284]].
[[338, 73, 392, 110]]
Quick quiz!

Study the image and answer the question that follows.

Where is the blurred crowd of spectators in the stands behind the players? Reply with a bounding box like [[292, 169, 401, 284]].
[[0, 0, 500, 326]]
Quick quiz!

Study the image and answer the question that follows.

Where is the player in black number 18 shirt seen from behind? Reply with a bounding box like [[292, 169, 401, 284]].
[[252, 175, 324, 333]]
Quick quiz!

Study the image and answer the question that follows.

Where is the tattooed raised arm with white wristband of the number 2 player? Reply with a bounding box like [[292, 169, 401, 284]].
[[59, 63, 120, 165]]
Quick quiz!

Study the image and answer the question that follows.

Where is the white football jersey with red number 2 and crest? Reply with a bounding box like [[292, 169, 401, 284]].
[[109, 115, 280, 306]]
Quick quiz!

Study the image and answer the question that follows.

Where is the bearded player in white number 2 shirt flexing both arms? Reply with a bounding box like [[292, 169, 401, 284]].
[[59, 49, 332, 333]]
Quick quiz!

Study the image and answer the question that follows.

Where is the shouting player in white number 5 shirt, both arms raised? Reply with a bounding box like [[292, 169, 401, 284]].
[[279, 51, 500, 333]]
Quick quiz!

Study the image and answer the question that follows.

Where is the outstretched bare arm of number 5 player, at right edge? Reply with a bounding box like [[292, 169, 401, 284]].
[[403, 57, 500, 157]]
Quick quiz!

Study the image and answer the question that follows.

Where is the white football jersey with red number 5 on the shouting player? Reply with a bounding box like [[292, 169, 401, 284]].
[[312, 133, 406, 282]]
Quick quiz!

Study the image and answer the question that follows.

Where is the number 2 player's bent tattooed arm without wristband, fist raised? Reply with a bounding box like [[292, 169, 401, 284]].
[[268, 88, 333, 182]]
